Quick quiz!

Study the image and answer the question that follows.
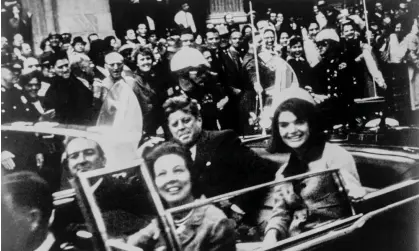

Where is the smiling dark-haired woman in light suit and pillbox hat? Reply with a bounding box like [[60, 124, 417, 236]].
[[264, 88, 365, 245]]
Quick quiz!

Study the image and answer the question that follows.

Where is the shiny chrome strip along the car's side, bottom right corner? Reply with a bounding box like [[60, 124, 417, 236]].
[[261, 195, 419, 251]]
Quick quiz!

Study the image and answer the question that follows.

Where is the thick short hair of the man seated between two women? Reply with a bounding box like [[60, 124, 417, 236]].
[[163, 95, 201, 121]]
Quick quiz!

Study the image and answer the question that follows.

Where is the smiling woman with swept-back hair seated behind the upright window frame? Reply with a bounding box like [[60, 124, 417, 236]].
[[127, 142, 236, 250]]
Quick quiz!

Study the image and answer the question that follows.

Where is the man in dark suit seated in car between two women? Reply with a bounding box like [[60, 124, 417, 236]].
[[163, 96, 278, 222]]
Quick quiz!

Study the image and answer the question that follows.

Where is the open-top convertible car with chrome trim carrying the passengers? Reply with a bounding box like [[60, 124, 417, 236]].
[[2, 122, 419, 251]]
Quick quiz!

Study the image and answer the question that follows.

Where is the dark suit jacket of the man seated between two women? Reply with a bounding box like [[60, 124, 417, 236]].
[[192, 130, 278, 221]]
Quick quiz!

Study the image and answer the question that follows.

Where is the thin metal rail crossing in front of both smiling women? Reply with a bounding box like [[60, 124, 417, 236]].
[[166, 168, 339, 214]]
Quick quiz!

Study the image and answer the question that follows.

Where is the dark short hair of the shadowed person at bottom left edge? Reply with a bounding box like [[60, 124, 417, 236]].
[[2, 171, 53, 223]]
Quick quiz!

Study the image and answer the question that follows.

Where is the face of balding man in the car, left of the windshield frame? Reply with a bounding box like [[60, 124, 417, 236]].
[[66, 138, 106, 176]]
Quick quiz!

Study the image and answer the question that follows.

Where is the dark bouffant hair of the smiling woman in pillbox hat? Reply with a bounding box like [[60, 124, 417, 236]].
[[267, 98, 325, 153]]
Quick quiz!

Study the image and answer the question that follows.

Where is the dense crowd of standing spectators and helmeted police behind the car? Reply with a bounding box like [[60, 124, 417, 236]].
[[2, 1, 419, 135]]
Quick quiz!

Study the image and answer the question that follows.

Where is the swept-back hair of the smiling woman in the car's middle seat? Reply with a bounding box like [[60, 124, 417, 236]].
[[143, 141, 198, 196]]
